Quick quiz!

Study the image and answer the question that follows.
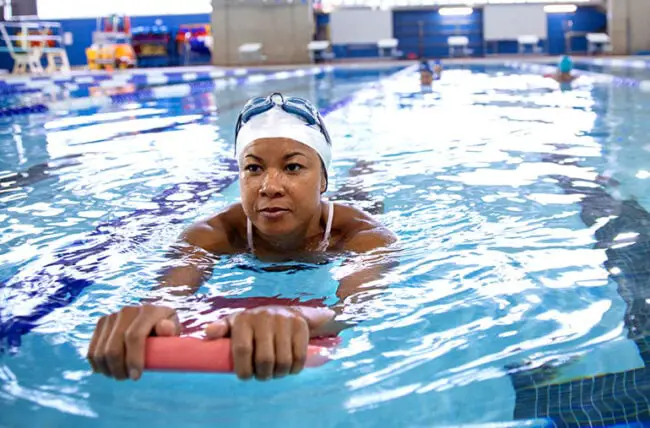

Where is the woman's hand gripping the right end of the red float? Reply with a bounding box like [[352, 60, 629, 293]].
[[205, 306, 334, 380]]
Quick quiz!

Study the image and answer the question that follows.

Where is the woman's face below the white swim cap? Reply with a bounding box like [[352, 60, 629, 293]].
[[239, 138, 326, 236]]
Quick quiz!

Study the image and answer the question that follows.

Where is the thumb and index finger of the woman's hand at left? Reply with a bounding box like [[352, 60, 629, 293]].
[[122, 305, 180, 380]]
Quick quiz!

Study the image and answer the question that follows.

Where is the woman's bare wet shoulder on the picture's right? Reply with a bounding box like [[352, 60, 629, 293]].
[[333, 204, 397, 252]]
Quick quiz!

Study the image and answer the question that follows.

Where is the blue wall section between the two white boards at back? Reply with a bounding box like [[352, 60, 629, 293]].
[[393, 9, 483, 58]]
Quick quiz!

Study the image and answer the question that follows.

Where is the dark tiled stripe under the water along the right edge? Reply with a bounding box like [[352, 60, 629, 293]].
[[510, 154, 650, 427]]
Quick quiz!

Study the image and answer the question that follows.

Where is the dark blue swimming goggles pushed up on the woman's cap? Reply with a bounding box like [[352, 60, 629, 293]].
[[235, 92, 332, 146]]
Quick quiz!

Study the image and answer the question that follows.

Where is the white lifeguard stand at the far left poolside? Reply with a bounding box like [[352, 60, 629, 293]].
[[0, 21, 70, 74]]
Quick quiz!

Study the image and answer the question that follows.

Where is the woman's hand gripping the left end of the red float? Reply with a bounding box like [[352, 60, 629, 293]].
[[88, 305, 181, 380]]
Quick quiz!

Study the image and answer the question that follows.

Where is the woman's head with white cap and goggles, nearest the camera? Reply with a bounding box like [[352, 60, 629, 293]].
[[235, 92, 332, 234]]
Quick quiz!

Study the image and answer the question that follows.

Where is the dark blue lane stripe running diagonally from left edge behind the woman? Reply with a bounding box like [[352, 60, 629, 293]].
[[0, 66, 416, 354]]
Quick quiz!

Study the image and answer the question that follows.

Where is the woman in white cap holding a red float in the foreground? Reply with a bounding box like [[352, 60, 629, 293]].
[[88, 93, 396, 380]]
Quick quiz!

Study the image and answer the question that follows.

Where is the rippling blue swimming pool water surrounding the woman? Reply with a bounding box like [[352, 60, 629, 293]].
[[0, 61, 650, 427]]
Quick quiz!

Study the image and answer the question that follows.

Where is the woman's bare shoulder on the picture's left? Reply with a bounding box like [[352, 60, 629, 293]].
[[181, 203, 246, 254]]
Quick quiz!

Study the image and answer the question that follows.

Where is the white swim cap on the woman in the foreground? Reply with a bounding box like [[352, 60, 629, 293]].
[[235, 106, 332, 171]]
